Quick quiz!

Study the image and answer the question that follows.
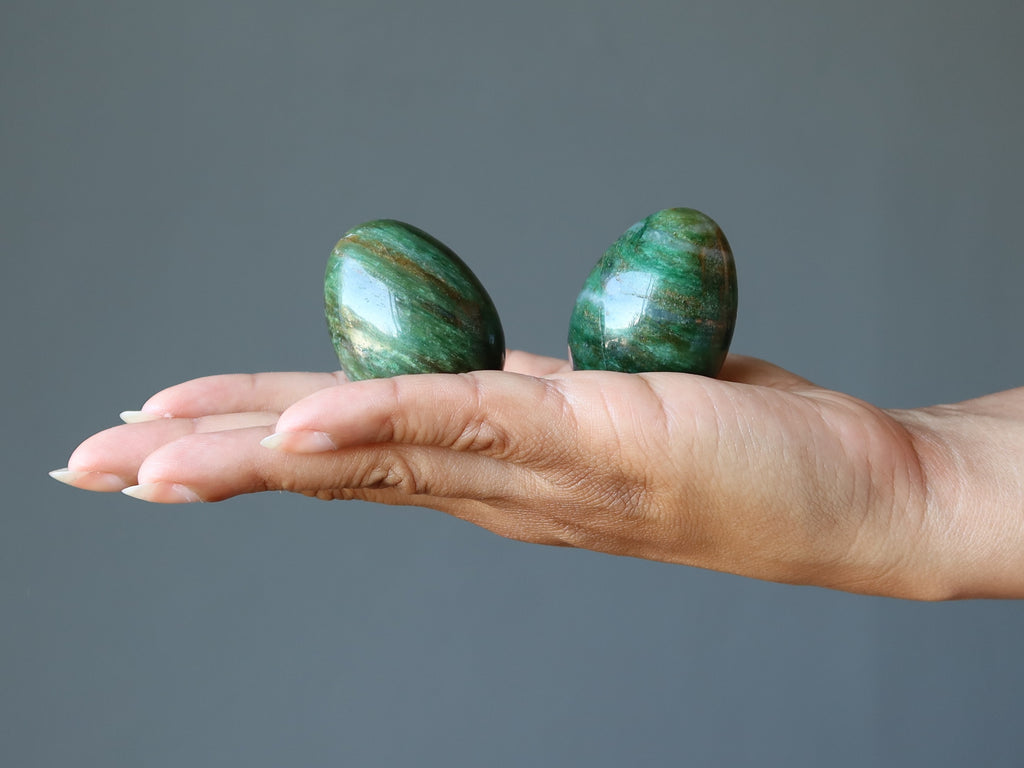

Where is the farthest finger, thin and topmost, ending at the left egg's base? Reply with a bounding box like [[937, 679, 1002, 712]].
[[126, 372, 345, 421]]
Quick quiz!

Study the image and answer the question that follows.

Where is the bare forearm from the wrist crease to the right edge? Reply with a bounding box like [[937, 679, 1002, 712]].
[[898, 387, 1024, 598]]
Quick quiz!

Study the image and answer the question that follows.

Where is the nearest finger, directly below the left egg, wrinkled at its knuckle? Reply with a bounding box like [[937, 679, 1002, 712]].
[[267, 371, 567, 458]]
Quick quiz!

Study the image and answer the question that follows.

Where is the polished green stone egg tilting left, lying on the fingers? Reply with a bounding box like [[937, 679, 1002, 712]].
[[324, 219, 505, 381]]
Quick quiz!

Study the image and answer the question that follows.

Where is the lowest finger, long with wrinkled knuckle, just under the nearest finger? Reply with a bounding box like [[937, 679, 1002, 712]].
[[125, 427, 540, 506]]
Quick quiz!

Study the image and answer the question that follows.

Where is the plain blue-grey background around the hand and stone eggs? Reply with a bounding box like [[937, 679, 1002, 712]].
[[0, 0, 1024, 767]]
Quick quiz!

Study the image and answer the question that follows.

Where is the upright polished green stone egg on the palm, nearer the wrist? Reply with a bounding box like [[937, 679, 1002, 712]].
[[569, 208, 736, 376]]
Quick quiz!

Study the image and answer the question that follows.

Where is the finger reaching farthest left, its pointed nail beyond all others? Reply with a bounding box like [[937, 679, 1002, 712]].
[[63, 413, 278, 490]]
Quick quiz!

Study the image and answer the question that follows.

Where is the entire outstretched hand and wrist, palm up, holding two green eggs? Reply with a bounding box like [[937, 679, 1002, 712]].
[[55, 351, 1024, 600]]
